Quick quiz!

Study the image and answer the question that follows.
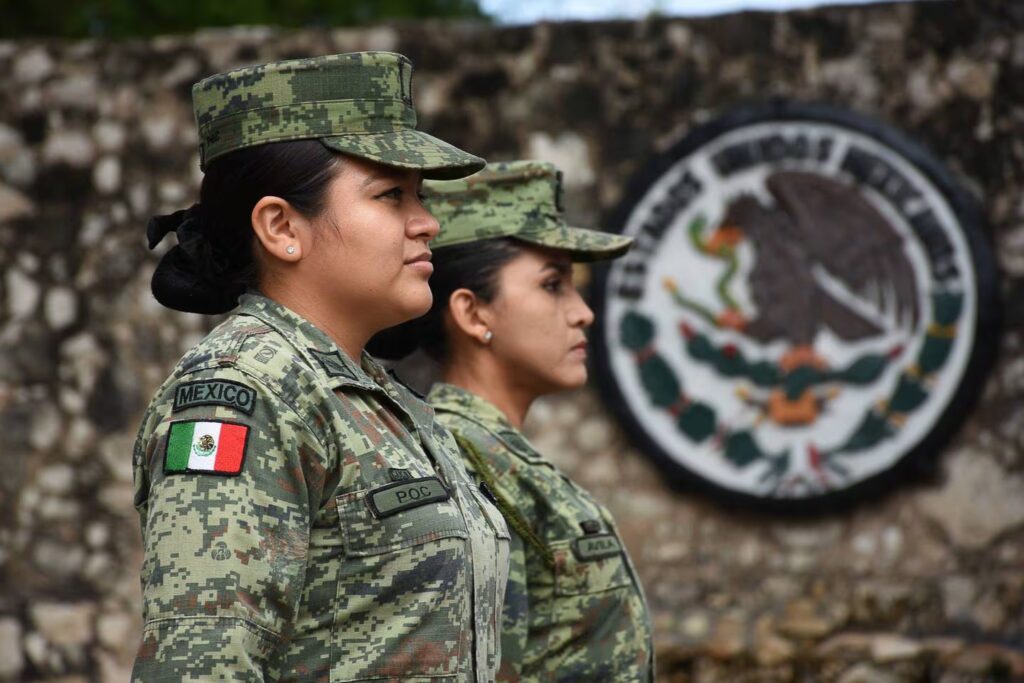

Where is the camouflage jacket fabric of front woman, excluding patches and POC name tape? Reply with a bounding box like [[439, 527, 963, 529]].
[[133, 295, 509, 683]]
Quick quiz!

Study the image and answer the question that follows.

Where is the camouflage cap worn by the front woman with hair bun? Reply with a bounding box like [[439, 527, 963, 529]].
[[193, 52, 484, 178]]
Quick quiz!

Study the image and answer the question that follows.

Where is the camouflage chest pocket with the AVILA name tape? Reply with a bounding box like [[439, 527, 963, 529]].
[[551, 533, 631, 596]]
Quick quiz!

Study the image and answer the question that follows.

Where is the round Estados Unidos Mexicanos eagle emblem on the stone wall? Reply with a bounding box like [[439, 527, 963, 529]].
[[594, 103, 997, 509]]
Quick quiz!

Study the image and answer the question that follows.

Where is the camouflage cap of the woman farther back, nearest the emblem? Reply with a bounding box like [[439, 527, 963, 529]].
[[423, 161, 633, 261]]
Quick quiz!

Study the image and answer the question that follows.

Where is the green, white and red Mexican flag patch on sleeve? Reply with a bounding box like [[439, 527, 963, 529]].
[[164, 420, 249, 476]]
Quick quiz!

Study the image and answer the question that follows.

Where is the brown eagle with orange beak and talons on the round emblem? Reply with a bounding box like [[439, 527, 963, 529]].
[[701, 171, 921, 425]]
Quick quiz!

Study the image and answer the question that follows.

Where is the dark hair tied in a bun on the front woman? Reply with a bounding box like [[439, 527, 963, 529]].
[[148, 140, 341, 313]]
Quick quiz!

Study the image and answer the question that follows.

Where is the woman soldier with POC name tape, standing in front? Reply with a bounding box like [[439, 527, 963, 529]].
[[134, 52, 508, 682]]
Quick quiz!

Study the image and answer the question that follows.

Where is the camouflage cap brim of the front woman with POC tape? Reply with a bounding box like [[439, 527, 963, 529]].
[[321, 129, 486, 180]]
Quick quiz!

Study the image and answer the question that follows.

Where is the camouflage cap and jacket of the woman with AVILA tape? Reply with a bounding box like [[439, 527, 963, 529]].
[[425, 161, 653, 683]]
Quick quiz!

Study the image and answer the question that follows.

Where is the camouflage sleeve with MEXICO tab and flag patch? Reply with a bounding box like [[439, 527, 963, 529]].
[[133, 368, 327, 683]]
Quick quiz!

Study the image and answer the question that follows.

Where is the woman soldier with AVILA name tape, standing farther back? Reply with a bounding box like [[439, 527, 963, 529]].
[[374, 162, 652, 683]]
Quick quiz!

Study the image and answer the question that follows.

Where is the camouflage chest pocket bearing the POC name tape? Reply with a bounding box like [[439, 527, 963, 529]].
[[331, 477, 472, 682]]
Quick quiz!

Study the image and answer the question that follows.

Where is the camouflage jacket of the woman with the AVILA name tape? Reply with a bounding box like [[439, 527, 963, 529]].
[[427, 384, 653, 683]]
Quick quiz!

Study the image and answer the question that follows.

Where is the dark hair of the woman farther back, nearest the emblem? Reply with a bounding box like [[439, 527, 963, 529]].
[[367, 238, 522, 362]]
